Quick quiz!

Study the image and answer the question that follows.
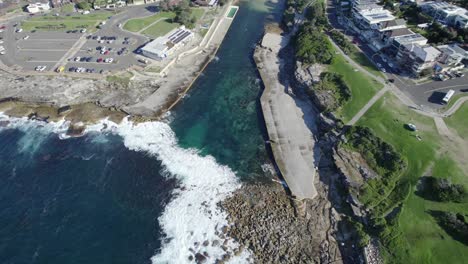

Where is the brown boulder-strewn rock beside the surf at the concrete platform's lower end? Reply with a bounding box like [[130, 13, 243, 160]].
[[222, 185, 341, 263]]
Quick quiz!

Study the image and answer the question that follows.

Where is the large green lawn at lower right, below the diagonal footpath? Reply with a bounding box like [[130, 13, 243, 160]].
[[358, 94, 468, 263]]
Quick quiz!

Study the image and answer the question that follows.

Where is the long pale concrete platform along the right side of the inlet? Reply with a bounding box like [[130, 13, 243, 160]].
[[255, 33, 317, 200]]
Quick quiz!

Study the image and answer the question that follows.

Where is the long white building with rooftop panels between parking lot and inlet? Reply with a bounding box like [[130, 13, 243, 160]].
[[141, 26, 193, 60]]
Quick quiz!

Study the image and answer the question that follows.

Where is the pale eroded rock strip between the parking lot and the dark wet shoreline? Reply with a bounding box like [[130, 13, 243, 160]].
[[0, 72, 159, 114]]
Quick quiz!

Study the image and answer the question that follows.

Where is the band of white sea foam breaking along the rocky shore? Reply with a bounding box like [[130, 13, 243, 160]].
[[0, 114, 251, 264]]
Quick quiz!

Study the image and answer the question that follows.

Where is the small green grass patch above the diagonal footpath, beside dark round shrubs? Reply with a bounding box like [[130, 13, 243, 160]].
[[328, 50, 383, 122]]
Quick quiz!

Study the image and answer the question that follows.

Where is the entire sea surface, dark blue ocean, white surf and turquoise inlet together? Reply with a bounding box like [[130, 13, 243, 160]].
[[0, 0, 282, 263]]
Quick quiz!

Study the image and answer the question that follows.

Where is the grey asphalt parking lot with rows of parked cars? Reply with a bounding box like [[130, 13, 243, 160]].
[[0, 8, 148, 73]]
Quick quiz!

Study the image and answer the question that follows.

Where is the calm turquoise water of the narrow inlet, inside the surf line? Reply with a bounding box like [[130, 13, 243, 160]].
[[171, 1, 278, 179]]
